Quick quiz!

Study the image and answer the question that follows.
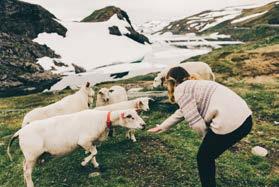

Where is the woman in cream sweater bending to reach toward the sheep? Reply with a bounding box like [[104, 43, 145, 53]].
[[149, 67, 252, 187]]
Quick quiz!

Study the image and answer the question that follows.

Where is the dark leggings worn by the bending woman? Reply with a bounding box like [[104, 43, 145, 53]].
[[197, 116, 252, 187]]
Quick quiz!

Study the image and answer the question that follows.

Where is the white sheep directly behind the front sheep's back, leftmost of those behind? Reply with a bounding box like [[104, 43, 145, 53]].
[[22, 82, 94, 127]]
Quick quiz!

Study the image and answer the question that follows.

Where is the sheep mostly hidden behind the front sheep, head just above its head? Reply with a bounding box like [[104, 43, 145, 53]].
[[94, 97, 152, 142]]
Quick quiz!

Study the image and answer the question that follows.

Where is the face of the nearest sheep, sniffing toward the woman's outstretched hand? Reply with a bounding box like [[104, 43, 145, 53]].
[[120, 110, 146, 130]]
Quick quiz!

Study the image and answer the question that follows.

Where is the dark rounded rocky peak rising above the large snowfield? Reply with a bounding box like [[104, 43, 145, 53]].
[[81, 6, 150, 44]]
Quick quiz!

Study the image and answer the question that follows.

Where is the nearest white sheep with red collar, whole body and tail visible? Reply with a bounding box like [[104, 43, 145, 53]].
[[7, 110, 145, 187]]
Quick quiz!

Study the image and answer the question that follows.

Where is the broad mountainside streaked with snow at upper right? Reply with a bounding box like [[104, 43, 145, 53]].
[[158, 1, 279, 41]]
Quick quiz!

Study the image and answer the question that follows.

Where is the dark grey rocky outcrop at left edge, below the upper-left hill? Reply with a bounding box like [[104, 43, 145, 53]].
[[0, 33, 61, 97]]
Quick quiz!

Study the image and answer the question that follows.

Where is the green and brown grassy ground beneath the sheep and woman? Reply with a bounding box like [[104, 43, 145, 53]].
[[0, 37, 279, 187]]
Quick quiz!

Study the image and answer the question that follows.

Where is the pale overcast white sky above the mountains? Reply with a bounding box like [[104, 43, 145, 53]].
[[23, 0, 274, 24]]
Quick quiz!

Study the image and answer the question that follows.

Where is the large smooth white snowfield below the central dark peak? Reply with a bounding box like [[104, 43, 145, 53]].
[[35, 16, 151, 74]]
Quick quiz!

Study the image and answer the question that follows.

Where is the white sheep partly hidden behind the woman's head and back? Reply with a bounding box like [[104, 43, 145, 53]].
[[153, 62, 215, 88]]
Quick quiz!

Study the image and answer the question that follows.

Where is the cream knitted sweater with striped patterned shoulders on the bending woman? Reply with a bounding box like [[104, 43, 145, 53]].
[[160, 80, 252, 135]]
